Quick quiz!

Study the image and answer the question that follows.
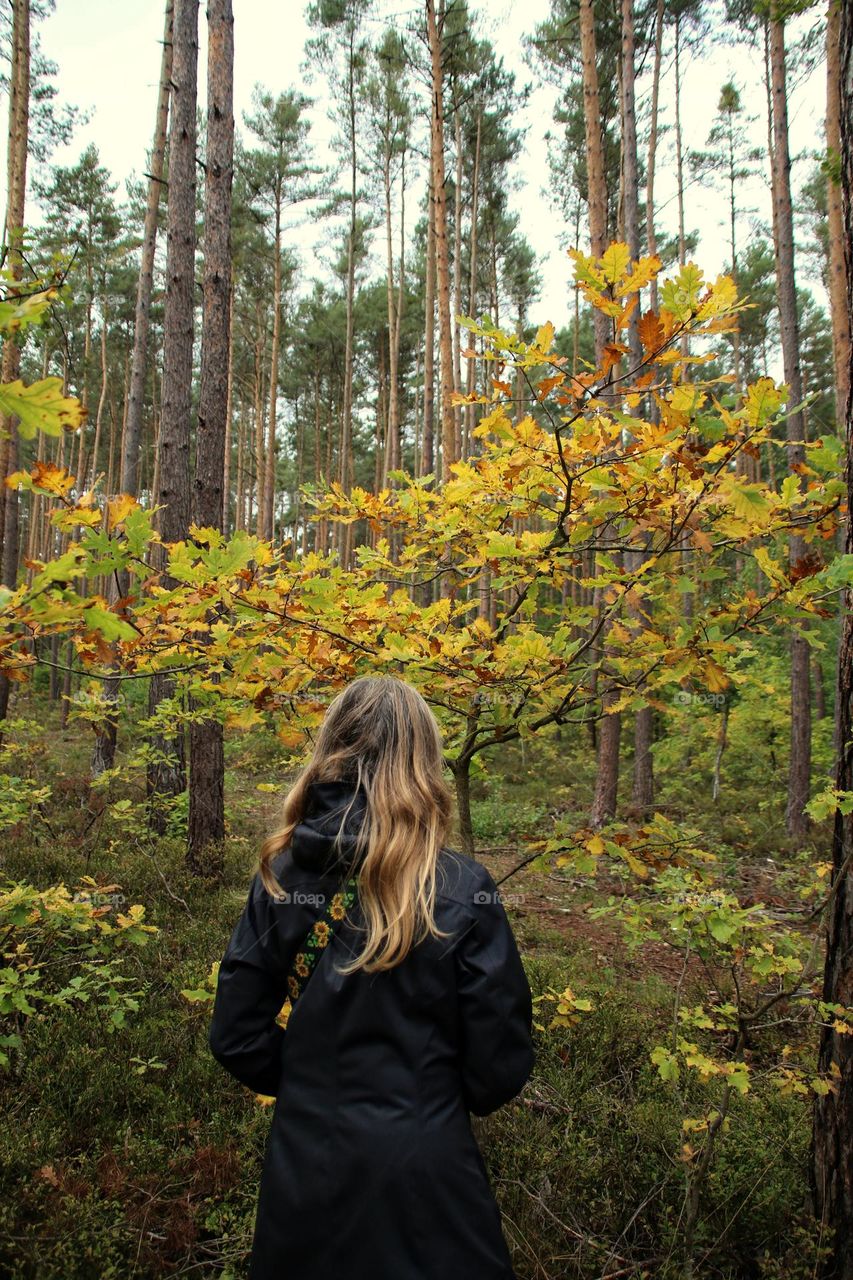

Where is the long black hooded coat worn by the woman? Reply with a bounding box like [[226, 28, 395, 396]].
[[210, 782, 534, 1280]]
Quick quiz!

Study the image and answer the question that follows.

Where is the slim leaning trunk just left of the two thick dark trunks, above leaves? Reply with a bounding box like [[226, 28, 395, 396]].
[[120, 0, 174, 497]]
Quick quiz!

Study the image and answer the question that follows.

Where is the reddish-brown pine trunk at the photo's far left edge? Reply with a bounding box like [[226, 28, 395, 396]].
[[0, 0, 29, 722]]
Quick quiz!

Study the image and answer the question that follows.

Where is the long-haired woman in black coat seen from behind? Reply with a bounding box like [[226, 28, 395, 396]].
[[210, 676, 534, 1280]]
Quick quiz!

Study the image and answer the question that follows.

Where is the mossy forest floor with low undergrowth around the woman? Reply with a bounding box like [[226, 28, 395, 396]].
[[0, 699, 826, 1280]]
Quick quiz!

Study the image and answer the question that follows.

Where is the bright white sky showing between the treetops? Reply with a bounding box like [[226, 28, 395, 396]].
[[3, 0, 825, 326]]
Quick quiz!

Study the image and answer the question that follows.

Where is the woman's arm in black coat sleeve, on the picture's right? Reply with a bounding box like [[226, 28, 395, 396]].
[[453, 864, 535, 1116]]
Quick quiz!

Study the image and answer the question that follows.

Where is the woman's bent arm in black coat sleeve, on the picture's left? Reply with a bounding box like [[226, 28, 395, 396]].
[[209, 876, 287, 1097]]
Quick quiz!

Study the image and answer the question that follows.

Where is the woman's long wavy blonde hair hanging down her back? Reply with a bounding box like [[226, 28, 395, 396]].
[[259, 676, 452, 973]]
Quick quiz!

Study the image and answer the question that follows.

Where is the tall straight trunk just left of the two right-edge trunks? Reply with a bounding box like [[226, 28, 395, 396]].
[[770, 18, 812, 840]]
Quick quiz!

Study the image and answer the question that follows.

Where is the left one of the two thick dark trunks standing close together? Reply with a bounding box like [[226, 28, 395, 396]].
[[147, 0, 199, 835]]
